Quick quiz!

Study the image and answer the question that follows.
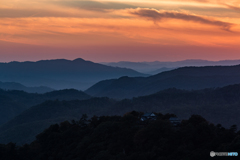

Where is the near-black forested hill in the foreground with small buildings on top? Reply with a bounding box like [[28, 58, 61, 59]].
[[0, 111, 240, 160]]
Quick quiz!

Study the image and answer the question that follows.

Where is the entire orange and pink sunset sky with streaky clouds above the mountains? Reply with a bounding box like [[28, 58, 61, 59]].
[[0, 0, 240, 62]]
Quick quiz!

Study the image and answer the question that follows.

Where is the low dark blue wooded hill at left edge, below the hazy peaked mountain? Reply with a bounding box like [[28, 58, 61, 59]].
[[0, 89, 90, 125]]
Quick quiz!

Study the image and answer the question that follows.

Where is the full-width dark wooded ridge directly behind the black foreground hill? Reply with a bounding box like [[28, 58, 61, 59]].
[[0, 85, 240, 144]]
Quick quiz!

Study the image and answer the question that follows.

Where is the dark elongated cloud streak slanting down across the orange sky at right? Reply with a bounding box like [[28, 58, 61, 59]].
[[129, 8, 233, 31]]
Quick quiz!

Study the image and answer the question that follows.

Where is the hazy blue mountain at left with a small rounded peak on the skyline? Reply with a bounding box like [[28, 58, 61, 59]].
[[0, 58, 145, 90]]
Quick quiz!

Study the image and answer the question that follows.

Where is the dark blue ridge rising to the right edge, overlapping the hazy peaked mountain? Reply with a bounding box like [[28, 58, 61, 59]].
[[85, 65, 240, 99]]
